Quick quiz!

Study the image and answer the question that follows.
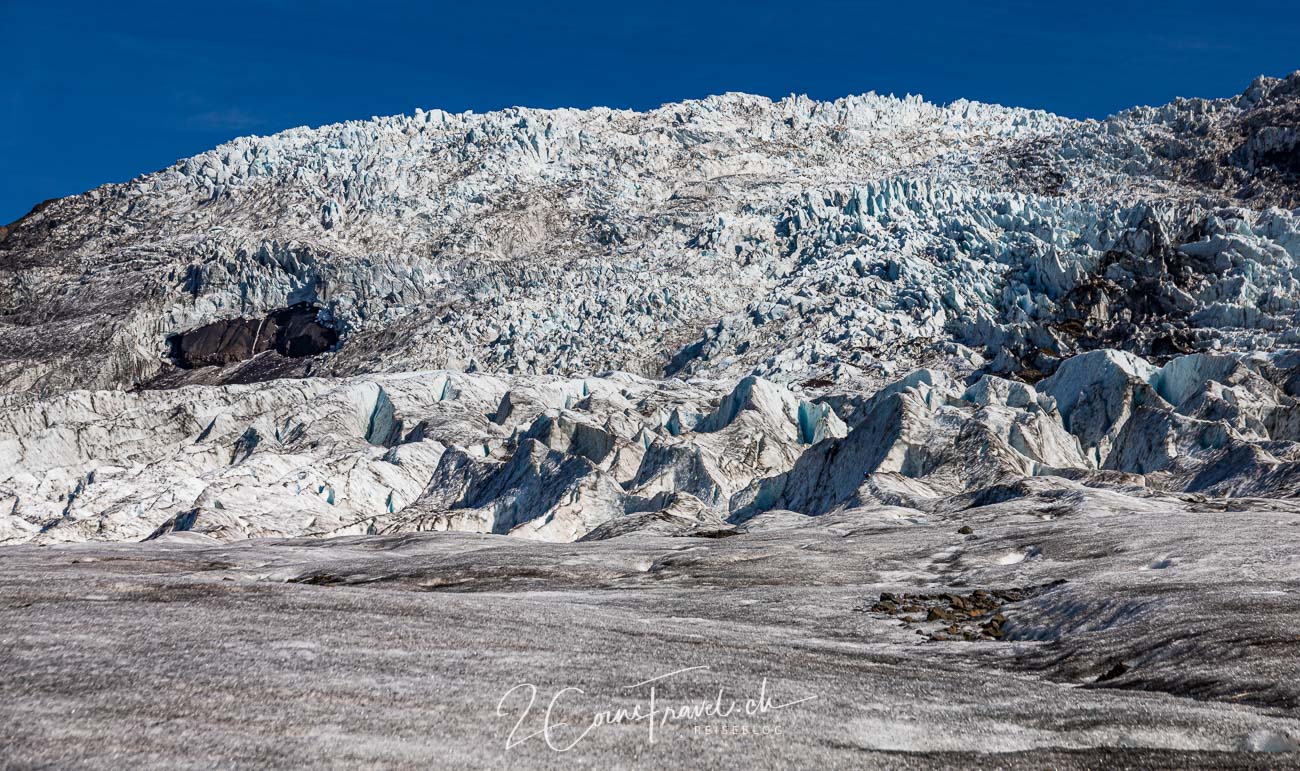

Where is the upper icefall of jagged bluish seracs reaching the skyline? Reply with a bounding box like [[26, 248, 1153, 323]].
[[0, 75, 1300, 393]]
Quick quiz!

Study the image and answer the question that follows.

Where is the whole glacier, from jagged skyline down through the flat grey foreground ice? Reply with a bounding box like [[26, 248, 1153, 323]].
[[0, 73, 1300, 767]]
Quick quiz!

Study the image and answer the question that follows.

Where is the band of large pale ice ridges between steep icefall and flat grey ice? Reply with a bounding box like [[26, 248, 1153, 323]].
[[0, 351, 1300, 542]]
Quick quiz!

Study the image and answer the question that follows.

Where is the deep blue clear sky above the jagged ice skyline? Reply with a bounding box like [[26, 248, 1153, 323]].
[[0, 0, 1300, 222]]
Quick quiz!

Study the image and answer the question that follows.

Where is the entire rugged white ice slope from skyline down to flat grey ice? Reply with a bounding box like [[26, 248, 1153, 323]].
[[0, 73, 1300, 542]]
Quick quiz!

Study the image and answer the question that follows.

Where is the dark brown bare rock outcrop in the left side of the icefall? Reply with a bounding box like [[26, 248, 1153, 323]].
[[168, 303, 338, 369]]
